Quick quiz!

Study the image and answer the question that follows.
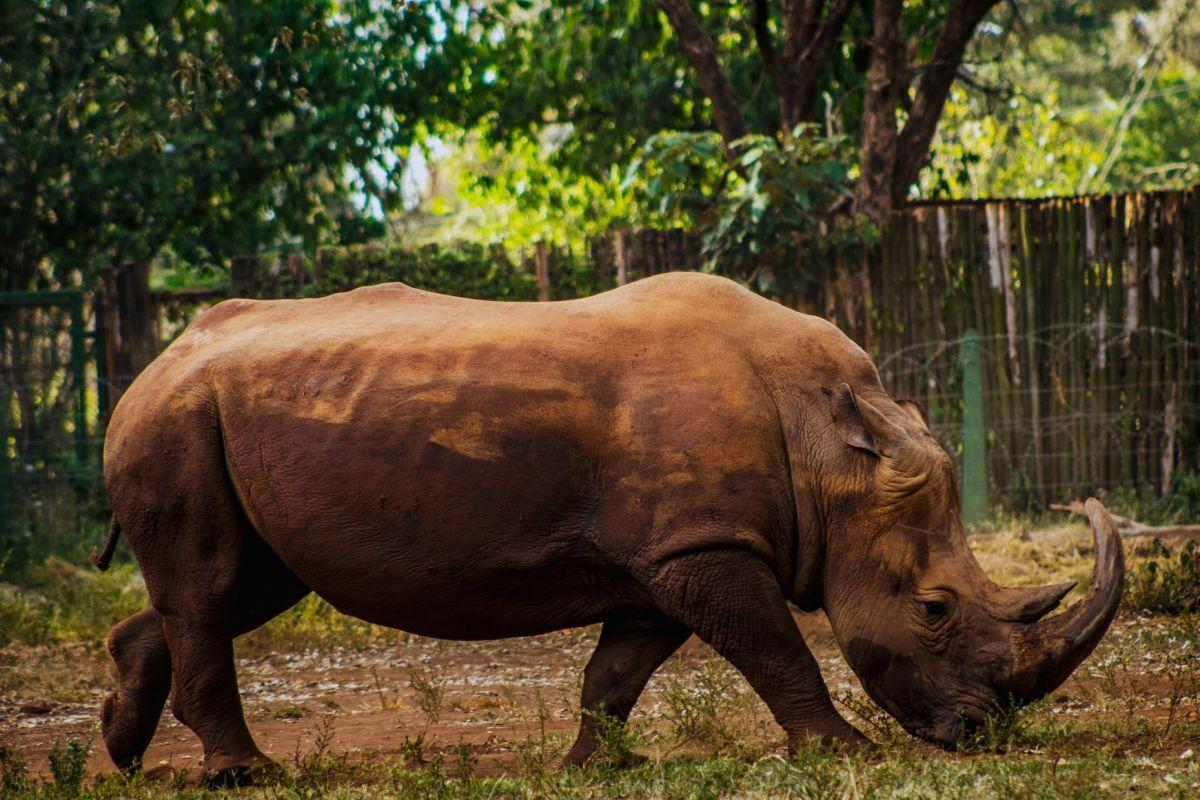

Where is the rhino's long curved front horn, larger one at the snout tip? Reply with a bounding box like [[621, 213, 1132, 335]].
[[1001, 498, 1124, 702]]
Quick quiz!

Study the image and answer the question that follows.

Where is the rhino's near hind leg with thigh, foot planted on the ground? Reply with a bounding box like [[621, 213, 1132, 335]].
[[106, 414, 308, 784]]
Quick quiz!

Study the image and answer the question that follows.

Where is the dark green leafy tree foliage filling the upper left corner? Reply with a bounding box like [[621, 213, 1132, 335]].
[[0, 0, 474, 289]]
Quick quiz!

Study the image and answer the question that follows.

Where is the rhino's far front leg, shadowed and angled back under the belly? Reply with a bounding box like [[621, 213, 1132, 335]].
[[564, 614, 691, 766]]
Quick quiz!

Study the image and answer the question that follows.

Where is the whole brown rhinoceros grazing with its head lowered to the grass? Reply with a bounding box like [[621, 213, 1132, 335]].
[[96, 273, 1124, 780]]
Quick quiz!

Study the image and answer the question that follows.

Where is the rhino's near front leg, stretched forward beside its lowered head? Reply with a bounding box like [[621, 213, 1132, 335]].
[[652, 551, 868, 750]]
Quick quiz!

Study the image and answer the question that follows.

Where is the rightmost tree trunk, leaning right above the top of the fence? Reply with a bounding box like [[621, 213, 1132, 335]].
[[893, 0, 1000, 200]]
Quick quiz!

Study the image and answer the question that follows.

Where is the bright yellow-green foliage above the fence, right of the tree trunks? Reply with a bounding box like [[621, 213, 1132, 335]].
[[922, 0, 1200, 198]]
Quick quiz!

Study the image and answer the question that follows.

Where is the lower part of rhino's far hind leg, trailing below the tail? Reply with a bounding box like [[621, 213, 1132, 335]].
[[101, 608, 170, 770]]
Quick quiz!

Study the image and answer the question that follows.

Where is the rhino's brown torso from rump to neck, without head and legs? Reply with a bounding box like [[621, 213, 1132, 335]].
[[106, 275, 881, 638]]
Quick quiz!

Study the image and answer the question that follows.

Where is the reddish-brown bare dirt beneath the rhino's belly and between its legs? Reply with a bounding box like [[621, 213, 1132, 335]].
[[0, 614, 857, 776]]
